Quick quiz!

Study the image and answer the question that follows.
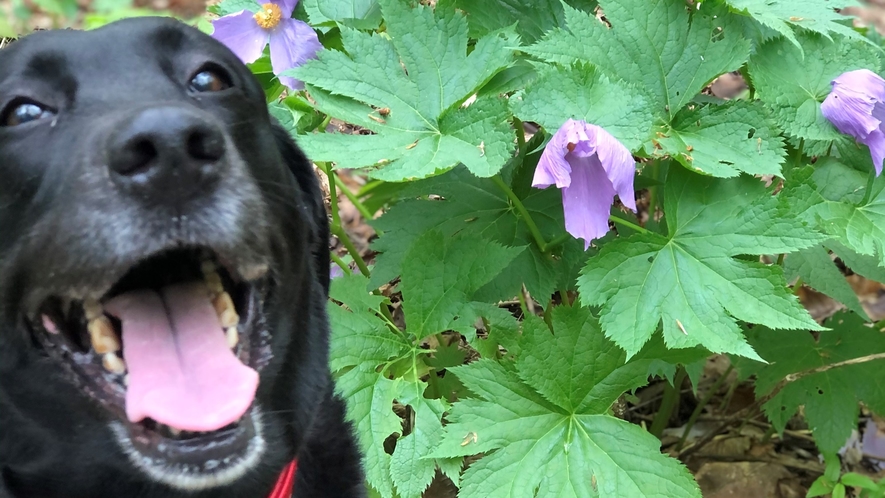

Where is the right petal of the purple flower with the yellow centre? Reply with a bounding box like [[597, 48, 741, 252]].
[[270, 19, 323, 90]]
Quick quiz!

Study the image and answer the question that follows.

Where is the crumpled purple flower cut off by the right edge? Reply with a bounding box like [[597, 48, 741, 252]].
[[820, 69, 885, 176]]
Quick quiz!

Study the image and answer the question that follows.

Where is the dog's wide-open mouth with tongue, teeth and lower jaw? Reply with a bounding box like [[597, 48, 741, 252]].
[[30, 248, 270, 486]]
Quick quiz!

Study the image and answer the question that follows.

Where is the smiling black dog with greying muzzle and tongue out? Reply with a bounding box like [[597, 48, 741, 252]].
[[0, 18, 363, 498]]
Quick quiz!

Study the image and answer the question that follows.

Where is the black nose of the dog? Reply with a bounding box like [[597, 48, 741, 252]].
[[108, 106, 225, 202]]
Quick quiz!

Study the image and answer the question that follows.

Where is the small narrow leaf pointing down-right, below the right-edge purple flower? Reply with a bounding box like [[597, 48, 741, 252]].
[[784, 245, 870, 321]]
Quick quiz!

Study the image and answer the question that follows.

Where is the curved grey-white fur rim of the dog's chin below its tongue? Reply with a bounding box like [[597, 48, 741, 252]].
[[109, 406, 267, 492]]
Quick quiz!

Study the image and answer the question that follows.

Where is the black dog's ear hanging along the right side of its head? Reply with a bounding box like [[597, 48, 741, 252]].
[[273, 123, 331, 294]]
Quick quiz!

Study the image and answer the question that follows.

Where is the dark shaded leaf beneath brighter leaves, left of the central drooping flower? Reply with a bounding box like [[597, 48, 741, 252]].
[[371, 168, 583, 302]]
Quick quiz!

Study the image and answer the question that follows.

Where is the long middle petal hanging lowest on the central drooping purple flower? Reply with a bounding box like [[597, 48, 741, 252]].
[[562, 154, 616, 250]]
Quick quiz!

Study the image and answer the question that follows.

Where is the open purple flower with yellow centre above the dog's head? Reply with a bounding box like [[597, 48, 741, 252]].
[[212, 0, 323, 90]]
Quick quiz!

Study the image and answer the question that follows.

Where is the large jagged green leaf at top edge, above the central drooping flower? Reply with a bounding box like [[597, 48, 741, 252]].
[[524, 0, 750, 121]]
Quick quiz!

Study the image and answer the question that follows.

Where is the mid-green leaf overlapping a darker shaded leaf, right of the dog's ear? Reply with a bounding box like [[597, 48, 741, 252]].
[[401, 230, 522, 337]]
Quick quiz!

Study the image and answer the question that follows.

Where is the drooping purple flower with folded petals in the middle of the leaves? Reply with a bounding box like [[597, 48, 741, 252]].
[[532, 119, 636, 249]]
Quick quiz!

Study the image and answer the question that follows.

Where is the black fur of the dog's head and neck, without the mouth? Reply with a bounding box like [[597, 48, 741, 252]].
[[0, 18, 363, 498]]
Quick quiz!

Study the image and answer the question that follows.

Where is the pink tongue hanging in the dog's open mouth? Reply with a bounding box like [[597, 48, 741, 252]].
[[104, 283, 258, 431]]
